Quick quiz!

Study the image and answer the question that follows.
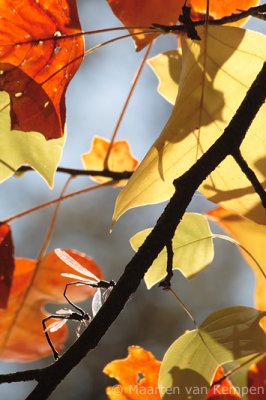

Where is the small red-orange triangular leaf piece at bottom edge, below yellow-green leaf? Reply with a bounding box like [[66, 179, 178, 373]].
[[206, 367, 241, 400]]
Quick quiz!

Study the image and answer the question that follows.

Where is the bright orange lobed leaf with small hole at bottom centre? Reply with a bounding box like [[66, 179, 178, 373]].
[[103, 346, 161, 400]]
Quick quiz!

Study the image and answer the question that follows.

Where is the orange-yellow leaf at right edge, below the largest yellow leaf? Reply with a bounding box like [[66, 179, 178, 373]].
[[207, 207, 266, 328]]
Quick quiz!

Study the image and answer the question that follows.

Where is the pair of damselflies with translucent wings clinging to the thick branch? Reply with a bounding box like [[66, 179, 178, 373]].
[[42, 249, 115, 360]]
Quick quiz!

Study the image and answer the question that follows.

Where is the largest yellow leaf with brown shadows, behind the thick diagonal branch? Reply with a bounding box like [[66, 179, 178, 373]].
[[113, 26, 266, 223]]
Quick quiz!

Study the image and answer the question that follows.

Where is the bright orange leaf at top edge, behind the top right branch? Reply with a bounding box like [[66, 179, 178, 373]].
[[190, 0, 259, 26]]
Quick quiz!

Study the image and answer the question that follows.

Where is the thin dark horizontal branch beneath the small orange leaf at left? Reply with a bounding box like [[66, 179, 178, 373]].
[[17, 165, 133, 181]]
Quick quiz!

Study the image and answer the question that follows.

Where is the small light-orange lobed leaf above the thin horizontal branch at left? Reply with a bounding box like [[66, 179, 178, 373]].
[[82, 136, 138, 186]]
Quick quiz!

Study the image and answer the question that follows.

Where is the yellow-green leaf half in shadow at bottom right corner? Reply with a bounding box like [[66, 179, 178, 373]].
[[159, 306, 266, 400]]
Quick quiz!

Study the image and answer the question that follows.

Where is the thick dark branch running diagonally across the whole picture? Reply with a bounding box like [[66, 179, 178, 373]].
[[14, 63, 266, 400]]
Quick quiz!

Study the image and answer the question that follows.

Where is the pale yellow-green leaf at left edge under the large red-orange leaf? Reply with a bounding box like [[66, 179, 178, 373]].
[[0, 91, 65, 187]]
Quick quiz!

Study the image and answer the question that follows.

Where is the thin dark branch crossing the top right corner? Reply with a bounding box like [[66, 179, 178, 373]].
[[152, 4, 266, 33]]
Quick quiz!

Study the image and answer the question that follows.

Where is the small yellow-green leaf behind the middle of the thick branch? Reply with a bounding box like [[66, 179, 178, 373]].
[[130, 213, 214, 289]]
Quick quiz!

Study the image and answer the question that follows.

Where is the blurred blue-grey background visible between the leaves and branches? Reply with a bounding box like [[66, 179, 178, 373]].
[[0, 0, 265, 400]]
